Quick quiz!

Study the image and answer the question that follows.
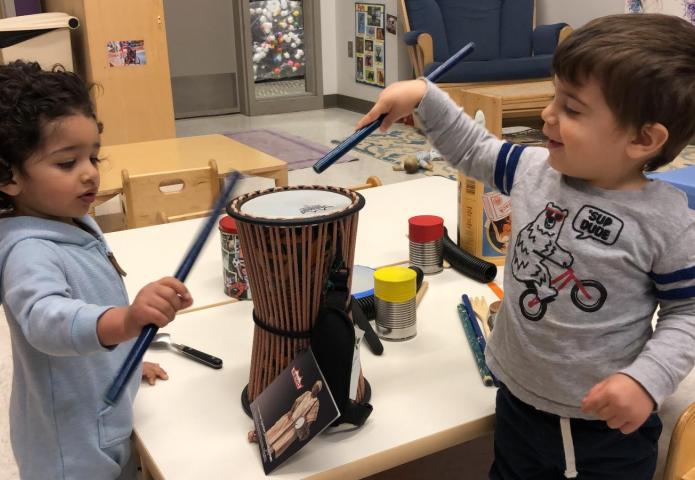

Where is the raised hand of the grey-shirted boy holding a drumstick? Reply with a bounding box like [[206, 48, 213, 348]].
[[357, 80, 427, 132]]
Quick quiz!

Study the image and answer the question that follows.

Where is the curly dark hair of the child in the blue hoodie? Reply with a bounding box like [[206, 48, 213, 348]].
[[0, 60, 102, 212]]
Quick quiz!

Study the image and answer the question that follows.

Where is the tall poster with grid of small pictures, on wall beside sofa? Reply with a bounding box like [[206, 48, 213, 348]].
[[355, 3, 386, 88]]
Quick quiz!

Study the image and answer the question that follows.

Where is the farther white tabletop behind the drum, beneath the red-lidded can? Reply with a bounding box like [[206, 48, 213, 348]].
[[106, 177, 458, 308]]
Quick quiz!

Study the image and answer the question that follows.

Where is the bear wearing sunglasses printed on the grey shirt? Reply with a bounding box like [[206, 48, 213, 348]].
[[512, 202, 574, 301]]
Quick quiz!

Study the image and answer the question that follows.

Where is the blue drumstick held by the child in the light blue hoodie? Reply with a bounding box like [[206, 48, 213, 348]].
[[104, 172, 241, 405]]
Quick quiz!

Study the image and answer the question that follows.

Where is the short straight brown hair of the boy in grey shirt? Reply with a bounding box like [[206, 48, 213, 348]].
[[553, 13, 695, 171]]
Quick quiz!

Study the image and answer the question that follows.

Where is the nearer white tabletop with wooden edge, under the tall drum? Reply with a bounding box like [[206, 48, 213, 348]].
[[135, 270, 496, 480]]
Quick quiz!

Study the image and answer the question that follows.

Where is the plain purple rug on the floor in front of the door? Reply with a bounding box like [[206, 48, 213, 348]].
[[222, 128, 357, 170]]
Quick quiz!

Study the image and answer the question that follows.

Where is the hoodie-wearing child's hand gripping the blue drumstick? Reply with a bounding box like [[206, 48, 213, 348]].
[[124, 277, 193, 336]]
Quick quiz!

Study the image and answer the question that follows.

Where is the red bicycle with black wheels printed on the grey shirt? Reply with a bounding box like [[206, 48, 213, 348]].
[[519, 257, 608, 322]]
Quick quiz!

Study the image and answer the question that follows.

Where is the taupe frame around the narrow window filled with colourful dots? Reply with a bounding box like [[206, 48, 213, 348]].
[[233, 0, 323, 116]]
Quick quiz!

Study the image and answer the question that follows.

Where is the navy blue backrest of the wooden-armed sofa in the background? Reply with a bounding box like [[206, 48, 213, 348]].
[[404, 0, 535, 62]]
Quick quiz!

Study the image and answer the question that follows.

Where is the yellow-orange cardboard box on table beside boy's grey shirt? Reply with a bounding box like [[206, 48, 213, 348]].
[[458, 174, 512, 265]]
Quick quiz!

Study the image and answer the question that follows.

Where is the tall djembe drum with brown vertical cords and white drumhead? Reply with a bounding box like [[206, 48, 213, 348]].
[[227, 186, 369, 415]]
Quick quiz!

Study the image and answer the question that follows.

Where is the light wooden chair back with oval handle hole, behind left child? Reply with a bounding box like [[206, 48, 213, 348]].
[[121, 160, 220, 228]]
